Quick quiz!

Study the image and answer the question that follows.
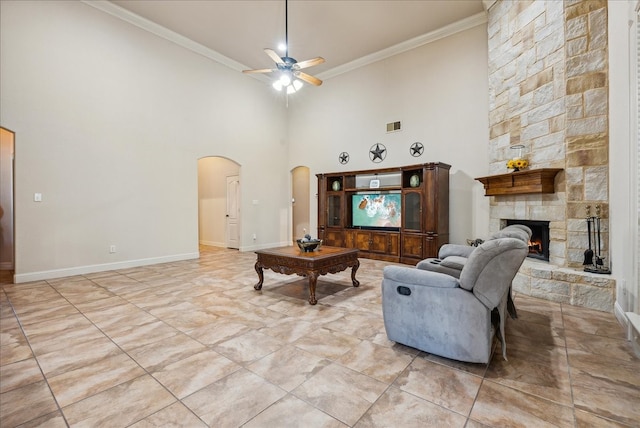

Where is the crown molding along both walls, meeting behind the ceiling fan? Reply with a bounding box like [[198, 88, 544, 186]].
[[81, 0, 484, 82]]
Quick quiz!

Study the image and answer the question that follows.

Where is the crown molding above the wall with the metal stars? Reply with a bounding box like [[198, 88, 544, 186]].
[[317, 12, 487, 80]]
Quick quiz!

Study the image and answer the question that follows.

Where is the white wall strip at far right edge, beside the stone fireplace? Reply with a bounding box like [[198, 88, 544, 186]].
[[608, 0, 640, 323]]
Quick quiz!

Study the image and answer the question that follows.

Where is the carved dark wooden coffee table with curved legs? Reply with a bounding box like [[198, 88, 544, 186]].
[[253, 246, 360, 305]]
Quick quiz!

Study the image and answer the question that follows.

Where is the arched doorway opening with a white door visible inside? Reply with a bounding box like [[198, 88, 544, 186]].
[[198, 156, 241, 249]]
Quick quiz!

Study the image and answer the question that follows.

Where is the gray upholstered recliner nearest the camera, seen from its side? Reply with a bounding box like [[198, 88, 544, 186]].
[[382, 238, 529, 363]]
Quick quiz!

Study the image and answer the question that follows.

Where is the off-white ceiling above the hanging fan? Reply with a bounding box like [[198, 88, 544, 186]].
[[111, 0, 484, 77]]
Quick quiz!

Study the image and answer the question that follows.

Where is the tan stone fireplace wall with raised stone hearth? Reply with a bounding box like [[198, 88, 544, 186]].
[[488, 0, 615, 311]]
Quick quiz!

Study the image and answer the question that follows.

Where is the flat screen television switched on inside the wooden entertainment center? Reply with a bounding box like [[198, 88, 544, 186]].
[[351, 192, 402, 230]]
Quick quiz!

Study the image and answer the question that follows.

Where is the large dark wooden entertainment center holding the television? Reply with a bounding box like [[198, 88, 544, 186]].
[[316, 162, 451, 265]]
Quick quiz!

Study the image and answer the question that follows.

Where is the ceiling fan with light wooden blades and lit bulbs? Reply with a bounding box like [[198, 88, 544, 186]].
[[242, 0, 324, 94]]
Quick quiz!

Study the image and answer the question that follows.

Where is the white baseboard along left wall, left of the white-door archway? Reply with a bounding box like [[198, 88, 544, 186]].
[[13, 252, 200, 284]]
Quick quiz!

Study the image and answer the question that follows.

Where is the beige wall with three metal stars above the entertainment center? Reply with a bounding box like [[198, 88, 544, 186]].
[[289, 24, 489, 243]]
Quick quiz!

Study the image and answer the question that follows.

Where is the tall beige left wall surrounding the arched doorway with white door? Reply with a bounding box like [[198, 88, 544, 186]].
[[0, 1, 290, 281]]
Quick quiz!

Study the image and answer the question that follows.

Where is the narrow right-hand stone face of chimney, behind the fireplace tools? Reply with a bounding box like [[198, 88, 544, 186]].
[[565, 0, 609, 267]]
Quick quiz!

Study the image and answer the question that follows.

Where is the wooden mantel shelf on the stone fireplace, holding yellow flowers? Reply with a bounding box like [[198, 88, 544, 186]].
[[476, 168, 562, 196]]
